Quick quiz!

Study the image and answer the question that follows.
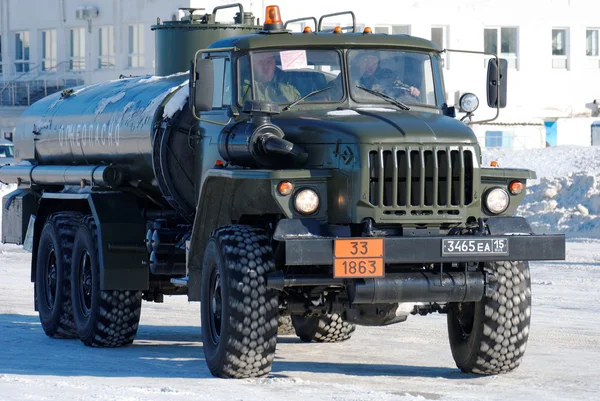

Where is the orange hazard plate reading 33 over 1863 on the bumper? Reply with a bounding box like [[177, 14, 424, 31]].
[[333, 238, 385, 278]]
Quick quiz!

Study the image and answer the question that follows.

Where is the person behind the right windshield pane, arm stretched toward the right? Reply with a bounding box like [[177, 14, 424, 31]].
[[353, 52, 421, 98]]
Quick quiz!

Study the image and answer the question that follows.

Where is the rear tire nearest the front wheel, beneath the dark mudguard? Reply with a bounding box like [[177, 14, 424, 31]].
[[71, 216, 142, 347]]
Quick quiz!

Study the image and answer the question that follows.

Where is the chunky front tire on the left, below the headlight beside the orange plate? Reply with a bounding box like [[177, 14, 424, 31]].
[[200, 225, 279, 379]]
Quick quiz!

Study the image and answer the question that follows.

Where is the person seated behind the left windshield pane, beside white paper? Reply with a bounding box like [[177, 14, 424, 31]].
[[241, 52, 300, 103]]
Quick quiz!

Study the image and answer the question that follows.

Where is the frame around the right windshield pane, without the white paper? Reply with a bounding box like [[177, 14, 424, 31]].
[[344, 46, 443, 109]]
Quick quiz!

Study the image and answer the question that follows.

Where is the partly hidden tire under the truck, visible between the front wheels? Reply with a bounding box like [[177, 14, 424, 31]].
[[292, 313, 356, 343]]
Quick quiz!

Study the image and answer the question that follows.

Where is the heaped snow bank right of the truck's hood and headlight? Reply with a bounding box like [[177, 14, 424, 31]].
[[482, 146, 600, 237]]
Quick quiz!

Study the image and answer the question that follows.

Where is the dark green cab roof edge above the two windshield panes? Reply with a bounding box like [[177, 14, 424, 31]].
[[210, 32, 441, 52]]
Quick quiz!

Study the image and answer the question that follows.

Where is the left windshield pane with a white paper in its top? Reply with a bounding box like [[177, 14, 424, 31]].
[[239, 50, 343, 104]]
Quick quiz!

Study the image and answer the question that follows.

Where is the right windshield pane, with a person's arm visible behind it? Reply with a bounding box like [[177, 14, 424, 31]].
[[348, 49, 436, 106]]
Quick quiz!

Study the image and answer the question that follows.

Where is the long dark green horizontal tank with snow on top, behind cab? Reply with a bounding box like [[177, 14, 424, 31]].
[[14, 73, 188, 184]]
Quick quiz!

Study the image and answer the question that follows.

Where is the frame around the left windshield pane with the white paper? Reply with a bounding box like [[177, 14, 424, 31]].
[[235, 46, 348, 108]]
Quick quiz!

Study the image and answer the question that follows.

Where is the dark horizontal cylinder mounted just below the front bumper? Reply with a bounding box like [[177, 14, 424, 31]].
[[348, 272, 485, 304]]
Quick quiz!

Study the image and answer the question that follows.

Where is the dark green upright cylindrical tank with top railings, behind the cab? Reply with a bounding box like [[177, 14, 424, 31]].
[[152, 3, 262, 76]]
